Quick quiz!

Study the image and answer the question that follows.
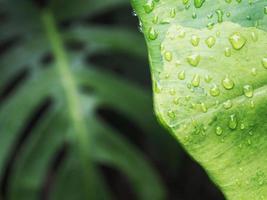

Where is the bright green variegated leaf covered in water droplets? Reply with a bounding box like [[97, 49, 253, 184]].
[[132, 0, 267, 200]]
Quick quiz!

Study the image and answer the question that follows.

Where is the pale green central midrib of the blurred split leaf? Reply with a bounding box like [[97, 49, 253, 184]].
[[43, 10, 96, 199]]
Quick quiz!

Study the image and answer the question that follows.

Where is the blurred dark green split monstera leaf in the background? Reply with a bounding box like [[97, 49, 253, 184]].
[[0, 0, 170, 200]]
